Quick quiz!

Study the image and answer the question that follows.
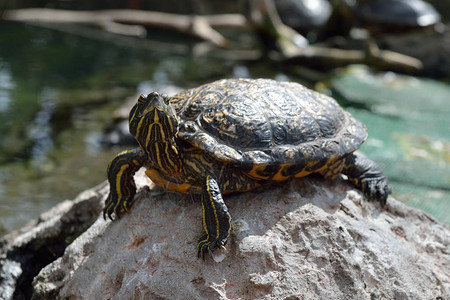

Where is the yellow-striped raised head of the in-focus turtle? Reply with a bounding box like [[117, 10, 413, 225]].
[[129, 93, 178, 147]]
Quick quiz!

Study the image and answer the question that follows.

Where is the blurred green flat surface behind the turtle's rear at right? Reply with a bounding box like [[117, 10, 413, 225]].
[[322, 66, 450, 224]]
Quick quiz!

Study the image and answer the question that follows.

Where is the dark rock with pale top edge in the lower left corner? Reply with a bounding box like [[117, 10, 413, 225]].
[[0, 183, 109, 299]]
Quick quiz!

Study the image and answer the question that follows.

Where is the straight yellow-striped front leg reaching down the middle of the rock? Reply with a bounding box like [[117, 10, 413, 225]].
[[197, 176, 231, 260]]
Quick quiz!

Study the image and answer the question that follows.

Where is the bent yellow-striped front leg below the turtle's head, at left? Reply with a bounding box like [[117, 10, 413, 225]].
[[103, 148, 146, 220]]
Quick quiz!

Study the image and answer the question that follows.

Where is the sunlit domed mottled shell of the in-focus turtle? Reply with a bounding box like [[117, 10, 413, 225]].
[[170, 79, 367, 165]]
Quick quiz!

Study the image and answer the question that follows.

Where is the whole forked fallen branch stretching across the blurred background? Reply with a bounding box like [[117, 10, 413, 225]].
[[0, 7, 422, 73]]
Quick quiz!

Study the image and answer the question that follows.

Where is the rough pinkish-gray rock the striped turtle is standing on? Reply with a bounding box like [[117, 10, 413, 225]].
[[29, 173, 450, 299]]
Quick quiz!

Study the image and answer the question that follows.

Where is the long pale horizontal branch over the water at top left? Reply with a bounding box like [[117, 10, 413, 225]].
[[2, 8, 248, 47]]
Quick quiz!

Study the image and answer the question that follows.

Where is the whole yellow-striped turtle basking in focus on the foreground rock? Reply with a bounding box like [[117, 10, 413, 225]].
[[103, 78, 391, 259]]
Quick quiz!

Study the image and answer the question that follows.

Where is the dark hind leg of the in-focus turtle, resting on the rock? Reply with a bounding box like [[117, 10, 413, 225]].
[[342, 153, 391, 206]]
